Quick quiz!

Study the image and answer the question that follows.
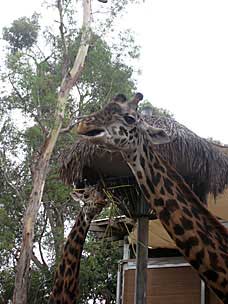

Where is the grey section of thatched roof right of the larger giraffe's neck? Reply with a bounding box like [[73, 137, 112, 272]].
[[147, 115, 228, 196]]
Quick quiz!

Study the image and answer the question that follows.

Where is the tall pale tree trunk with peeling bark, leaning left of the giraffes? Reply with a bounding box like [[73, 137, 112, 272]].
[[13, 0, 91, 304]]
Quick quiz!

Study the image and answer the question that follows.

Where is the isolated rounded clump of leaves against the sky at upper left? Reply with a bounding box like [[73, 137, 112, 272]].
[[3, 14, 40, 53]]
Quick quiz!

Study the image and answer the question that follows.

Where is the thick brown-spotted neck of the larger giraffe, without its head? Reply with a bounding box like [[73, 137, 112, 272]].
[[123, 141, 228, 303]]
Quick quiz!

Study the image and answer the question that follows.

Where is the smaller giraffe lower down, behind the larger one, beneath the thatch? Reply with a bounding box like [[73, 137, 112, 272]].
[[49, 187, 107, 304]]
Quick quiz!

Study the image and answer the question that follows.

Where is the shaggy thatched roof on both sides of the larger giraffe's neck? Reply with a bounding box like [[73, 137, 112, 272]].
[[60, 115, 228, 204]]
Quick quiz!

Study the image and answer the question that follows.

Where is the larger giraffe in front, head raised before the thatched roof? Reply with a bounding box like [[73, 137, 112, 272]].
[[77, 93, 228, 303]]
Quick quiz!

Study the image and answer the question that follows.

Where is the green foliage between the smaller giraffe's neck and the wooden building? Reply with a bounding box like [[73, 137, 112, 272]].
[[79, 236, 122, 304]]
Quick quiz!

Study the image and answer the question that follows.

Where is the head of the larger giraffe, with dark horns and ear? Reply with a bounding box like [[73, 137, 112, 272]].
[[77, 93, 170, 152]]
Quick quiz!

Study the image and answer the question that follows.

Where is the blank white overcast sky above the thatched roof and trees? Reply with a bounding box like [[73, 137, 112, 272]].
[[0, 0, 228, 143]]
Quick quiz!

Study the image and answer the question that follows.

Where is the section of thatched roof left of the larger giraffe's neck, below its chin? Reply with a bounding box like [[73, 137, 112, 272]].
[[60, 138, 133, 186]]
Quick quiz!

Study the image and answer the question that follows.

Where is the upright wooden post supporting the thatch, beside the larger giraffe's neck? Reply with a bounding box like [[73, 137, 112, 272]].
[[134, 216, 149, 304]]
